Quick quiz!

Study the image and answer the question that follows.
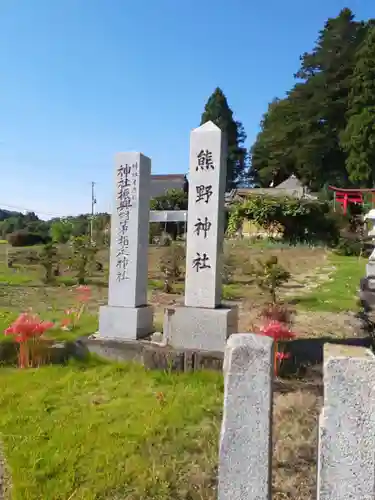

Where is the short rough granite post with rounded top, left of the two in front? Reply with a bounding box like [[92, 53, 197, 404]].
[[218, 334, 273, 500]]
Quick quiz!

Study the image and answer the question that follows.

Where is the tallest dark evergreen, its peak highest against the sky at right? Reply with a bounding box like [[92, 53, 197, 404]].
[[292, 9, 365, 188]]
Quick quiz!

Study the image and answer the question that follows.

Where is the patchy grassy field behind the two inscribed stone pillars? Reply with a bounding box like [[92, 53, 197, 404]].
[[0, 241, 366, 342]]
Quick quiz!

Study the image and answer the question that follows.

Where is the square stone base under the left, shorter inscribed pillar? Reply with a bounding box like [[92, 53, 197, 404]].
[[98, 306, 154, 340]]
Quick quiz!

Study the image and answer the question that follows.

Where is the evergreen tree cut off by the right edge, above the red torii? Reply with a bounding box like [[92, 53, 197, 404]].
[[341, 27, 375, 187]]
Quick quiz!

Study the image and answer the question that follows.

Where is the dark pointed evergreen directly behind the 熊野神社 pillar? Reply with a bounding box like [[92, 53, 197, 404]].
[[201, 88, 248, 191]]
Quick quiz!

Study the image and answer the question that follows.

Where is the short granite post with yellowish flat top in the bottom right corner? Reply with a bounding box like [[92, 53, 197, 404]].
[[317, 345, 375, 500]]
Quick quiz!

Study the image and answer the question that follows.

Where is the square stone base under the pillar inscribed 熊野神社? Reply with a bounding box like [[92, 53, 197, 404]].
[[163, 306, 238, 352]]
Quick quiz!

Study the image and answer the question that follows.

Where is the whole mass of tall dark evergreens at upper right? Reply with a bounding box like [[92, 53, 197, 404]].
[[250, 9, 375, 190]]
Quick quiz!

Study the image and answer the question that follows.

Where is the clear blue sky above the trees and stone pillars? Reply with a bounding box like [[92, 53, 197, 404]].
[[0, 0, 375, 218]]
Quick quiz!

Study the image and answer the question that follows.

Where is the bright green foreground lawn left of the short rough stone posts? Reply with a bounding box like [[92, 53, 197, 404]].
[[0, 361, 222, 500]]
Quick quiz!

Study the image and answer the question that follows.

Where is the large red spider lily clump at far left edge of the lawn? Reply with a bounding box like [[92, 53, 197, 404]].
[[4, 312, 54, 368]]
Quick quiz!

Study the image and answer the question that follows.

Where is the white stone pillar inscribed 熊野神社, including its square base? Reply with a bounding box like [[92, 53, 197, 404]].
[[163, 122, 238, 352]]
